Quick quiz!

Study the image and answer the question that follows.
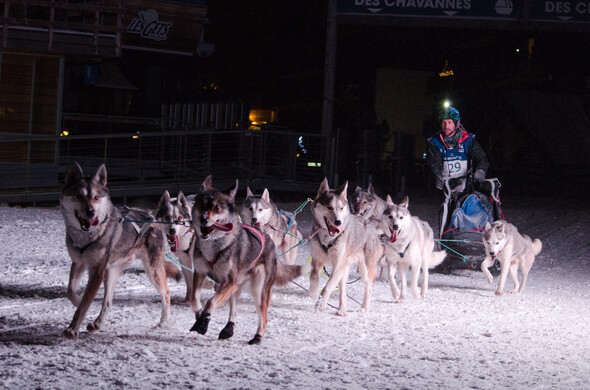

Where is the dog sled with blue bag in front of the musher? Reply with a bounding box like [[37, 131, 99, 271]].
[[436, 177, 504, 273]]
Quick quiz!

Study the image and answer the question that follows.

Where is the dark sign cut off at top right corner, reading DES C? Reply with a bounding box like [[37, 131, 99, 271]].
[[533, 0, 590, 22]]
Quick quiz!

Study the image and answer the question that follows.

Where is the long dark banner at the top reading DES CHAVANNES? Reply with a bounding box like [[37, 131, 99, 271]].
[[338, 0, 524, 20]]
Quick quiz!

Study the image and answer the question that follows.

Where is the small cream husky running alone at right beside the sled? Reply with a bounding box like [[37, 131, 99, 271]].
[[481, 220, 543, 296]]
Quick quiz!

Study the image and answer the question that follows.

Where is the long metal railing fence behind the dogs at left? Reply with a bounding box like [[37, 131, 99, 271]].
[[0, 106, 325, 203]]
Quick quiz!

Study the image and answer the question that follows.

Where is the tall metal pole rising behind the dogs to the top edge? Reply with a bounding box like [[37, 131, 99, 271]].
[[322, 0, 338, 181]]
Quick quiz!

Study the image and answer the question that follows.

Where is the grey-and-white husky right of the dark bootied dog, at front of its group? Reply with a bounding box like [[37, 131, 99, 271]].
[[309, 179, 383, 316]]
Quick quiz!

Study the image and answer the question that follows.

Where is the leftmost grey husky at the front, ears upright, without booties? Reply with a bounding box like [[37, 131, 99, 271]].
[[60, 163, 180, 339]]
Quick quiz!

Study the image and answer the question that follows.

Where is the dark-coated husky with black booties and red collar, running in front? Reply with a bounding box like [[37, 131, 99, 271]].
[[191, 176, 305, 344]]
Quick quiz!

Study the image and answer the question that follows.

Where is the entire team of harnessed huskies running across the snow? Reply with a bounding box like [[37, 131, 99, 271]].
[[60, 163, 542, 344]]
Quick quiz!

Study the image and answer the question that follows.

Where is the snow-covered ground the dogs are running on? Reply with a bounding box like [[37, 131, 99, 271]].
[[0, 194, 590, 389]]
